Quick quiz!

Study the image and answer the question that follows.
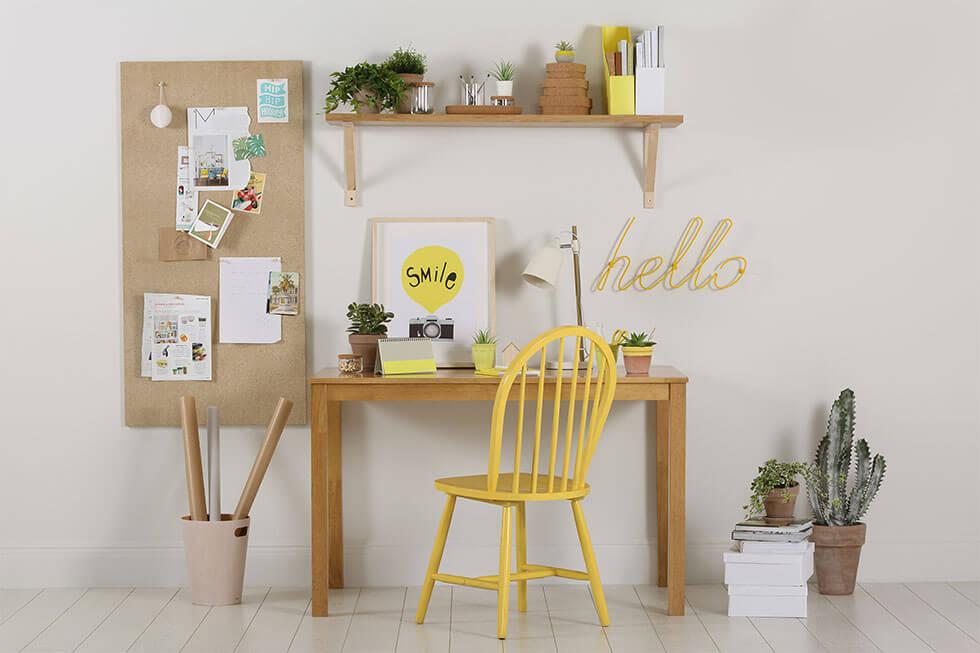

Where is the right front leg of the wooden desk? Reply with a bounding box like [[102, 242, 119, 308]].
[[667, 383, 687, 616]]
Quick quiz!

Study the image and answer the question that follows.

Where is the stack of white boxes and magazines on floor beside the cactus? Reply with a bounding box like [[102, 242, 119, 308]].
[[725, 518, 813, 617]]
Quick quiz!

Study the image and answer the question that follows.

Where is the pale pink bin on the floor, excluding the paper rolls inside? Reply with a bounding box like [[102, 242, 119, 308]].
[[180, 514, 249, 605]]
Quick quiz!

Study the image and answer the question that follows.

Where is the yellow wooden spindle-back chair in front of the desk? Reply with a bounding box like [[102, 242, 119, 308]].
[[415, 326, 616, 639]]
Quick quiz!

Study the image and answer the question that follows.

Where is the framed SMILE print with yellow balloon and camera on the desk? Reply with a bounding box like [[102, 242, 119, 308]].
[[371, 218, 496, 367]]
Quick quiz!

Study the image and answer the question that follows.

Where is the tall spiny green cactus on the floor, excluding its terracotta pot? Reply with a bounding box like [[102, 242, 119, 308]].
[[807, 388, 885, 526]]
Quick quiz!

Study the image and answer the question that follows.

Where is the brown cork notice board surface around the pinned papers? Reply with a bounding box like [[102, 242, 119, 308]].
[[120, 61, 306, 426]]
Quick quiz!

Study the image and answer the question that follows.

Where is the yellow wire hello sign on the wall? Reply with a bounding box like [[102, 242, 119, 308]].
[[595, 216, 748, 292]]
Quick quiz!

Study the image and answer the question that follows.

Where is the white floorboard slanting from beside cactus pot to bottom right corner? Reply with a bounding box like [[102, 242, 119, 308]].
[[861, 583, 980, 653]]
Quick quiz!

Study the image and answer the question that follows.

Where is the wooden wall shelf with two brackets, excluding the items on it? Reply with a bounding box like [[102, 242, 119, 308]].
[[324, 113, 684, 209]]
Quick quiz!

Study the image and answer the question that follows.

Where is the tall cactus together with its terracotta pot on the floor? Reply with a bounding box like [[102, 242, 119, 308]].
[[807, 388, 885, 595]]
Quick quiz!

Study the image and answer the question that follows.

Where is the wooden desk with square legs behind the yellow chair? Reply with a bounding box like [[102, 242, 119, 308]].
[[310, 366, 687, 617]]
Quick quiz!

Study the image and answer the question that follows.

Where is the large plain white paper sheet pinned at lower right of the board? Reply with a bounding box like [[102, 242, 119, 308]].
[[218, 257, 282, 344]]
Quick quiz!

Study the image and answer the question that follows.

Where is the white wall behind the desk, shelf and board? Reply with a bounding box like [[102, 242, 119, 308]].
[[0, 0, 980, 586]]
